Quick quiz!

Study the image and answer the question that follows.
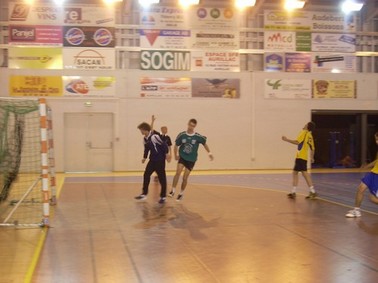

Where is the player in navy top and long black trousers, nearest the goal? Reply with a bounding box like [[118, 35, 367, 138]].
[[135, 122, 170, 203]]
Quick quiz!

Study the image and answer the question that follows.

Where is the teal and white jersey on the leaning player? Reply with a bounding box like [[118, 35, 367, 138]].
[[175, 132, 206, 162]]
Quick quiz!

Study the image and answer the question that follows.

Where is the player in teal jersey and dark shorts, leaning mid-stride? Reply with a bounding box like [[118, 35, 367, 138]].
[[168, 119, 214, 201]]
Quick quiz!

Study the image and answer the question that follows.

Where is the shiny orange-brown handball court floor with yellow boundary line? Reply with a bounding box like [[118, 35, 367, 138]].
[[0, 171, 378, 283]]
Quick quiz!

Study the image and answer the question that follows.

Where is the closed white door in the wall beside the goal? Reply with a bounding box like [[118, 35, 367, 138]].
[[64, 113, 113, 172]]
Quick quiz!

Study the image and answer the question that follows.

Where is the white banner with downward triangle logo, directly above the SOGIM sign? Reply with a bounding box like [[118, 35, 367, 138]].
[[140, 29, 191, 49]]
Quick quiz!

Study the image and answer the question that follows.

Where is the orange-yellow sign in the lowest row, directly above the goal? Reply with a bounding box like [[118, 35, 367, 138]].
[[9, 76, 63, 96]]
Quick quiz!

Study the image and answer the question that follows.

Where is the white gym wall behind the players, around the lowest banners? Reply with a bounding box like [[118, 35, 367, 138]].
[[0, 69, 378, 172]]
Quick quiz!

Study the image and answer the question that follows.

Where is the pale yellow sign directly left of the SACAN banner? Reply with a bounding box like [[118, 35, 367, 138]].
[[8, 46, 63, 69]]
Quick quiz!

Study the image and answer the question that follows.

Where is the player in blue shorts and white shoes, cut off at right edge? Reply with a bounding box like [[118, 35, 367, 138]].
[[345, 132, 378, 218]]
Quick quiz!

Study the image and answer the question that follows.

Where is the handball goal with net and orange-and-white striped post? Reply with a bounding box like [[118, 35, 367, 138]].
[[0, 98, 56, 229]]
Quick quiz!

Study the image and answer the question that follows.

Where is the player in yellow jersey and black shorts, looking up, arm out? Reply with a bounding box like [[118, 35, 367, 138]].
[[282, 122, 317, 199]]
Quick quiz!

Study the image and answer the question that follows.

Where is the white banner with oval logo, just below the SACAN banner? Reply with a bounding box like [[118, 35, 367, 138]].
[[63, 76, 116, 97]]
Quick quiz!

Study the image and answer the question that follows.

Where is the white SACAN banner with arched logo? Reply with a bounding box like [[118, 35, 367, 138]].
[[63, 47, 115, 70]]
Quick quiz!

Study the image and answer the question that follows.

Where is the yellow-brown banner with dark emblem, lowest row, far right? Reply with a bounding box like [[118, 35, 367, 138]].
[[312, 80, 357, 98]]
